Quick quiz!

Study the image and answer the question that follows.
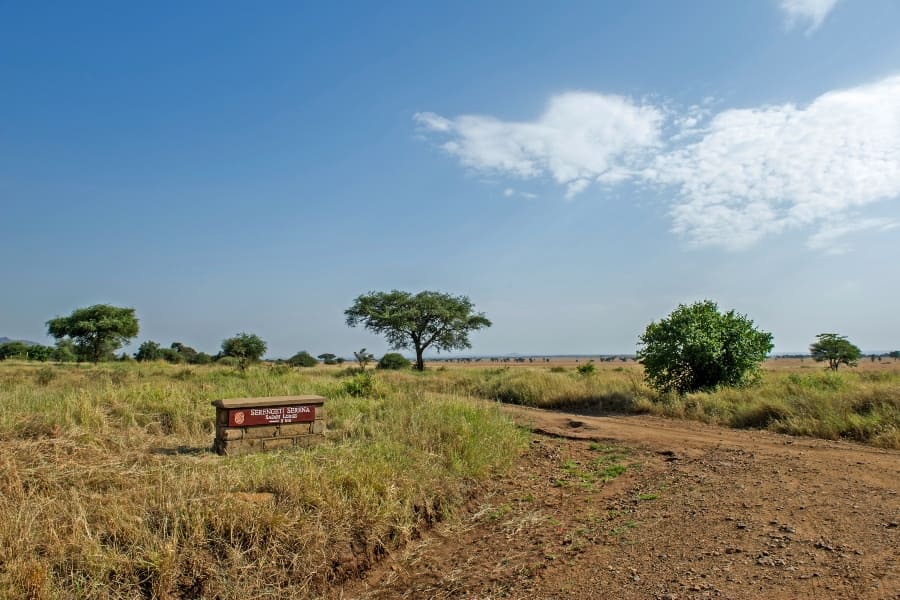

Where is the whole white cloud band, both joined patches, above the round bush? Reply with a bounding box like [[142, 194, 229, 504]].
[[415, 76, 900, 249]]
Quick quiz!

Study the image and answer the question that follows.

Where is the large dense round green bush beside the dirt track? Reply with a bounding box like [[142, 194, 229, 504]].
[[637, 300, 773, 394]]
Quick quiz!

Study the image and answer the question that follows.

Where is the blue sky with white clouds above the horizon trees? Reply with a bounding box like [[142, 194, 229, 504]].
[[0, 0, 900, 357]]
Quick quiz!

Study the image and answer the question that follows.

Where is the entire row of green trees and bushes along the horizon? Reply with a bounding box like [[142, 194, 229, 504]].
[[0, 300, 900, 394]]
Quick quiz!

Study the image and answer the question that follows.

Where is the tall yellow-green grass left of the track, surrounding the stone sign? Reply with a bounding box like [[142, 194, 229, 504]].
[[0, 363, 525, 599]]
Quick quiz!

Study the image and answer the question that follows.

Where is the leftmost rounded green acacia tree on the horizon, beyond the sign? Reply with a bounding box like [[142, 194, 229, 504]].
[[47, 304, 138, 362]]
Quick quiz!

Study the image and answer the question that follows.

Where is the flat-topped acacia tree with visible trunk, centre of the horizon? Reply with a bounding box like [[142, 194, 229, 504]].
[[344, 290, 491, 371]]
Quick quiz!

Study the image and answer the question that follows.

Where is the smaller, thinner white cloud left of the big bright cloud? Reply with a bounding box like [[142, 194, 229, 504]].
[[414, 92, 663, 190]]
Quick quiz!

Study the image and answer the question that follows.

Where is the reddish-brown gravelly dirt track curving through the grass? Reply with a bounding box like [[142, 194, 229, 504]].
[[333, 407, 900, 599]]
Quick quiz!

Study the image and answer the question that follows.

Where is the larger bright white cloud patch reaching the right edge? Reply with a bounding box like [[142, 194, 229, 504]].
[[645, 76, 900, 248]]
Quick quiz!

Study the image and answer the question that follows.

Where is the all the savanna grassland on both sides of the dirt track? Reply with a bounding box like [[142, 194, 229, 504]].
[[0, 361, 900, 598]]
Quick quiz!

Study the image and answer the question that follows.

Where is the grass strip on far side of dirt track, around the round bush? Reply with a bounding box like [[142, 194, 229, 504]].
[[384, 360, 900, 448]]
